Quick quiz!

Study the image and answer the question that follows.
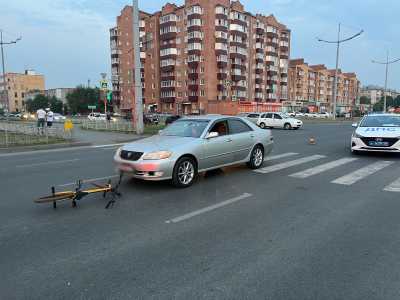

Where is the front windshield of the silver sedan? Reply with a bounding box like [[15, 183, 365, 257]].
[[161, 120, 209, 138]]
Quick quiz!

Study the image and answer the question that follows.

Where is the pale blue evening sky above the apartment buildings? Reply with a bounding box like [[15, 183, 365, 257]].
[[0, 0, 400, 90]]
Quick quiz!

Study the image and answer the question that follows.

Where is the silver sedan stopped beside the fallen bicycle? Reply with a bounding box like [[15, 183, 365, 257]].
[[114, 115, 273, 187]]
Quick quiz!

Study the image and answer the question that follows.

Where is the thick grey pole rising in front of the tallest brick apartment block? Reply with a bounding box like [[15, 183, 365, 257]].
[[132, 0, 144, 134]]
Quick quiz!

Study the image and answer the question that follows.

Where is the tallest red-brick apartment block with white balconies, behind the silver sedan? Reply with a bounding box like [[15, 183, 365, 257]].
[[110, 0, 290, 114]]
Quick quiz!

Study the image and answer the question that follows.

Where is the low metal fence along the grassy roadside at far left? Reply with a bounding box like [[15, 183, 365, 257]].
[[0, 121, 73, 147]]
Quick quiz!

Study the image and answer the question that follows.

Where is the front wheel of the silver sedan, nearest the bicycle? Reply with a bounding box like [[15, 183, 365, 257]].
[[172, 157, 197, 188]]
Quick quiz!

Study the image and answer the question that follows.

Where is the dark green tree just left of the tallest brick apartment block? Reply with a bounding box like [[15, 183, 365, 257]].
[[67, 86, 101, 114]]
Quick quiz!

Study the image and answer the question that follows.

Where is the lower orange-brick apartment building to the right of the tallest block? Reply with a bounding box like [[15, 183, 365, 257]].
[[287, 59, 360, 112]]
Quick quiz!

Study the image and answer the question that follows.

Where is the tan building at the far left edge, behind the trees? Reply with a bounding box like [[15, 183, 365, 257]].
[[0, 70, 45, 112]]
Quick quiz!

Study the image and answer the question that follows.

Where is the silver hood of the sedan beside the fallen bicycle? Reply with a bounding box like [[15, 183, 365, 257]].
[[122, 135, 196, 153]]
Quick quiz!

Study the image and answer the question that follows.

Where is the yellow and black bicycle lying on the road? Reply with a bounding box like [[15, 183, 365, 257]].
[[33, 173, 123, 209]]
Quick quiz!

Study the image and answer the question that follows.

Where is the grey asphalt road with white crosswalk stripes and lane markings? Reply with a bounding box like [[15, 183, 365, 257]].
[[0, 124, 400, 300]]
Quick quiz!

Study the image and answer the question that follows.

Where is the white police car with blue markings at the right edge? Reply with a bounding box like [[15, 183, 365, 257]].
[[351, 114, 400, 154]]
